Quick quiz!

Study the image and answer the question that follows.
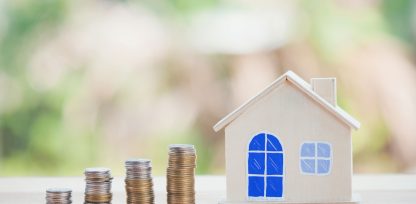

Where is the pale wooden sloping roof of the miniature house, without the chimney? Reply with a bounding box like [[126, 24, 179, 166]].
[[214, 71, 360, 132]]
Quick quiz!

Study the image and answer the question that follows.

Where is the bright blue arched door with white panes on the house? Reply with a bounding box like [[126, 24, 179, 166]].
[[247, 133, 284, 200]]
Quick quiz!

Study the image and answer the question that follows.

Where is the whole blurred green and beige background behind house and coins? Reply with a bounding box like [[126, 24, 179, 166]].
[[0, 0, 416, 176]]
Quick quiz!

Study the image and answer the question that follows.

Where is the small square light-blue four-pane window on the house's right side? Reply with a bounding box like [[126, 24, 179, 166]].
[[300, 142, 332, 175]]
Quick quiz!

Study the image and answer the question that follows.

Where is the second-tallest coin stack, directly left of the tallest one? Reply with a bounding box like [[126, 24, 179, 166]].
[[125, 159, 155, 204]]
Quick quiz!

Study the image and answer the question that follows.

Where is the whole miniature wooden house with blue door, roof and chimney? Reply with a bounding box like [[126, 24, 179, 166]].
[[214, 71, 360, 204]]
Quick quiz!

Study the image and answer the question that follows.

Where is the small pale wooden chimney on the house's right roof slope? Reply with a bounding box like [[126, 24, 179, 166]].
[[311, 78, 337, 106]]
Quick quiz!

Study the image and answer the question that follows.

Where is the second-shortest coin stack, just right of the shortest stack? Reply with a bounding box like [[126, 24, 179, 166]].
[[84, 168, 113, 204]]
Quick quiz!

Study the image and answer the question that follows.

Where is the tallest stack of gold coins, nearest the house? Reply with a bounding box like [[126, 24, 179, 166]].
[[166, 144, 196, 204]]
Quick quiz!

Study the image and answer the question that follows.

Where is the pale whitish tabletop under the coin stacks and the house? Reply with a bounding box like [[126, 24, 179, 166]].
[[0, 174, 416, 204]]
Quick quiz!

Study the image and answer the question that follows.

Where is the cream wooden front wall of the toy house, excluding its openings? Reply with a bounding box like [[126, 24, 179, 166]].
[[225, 81, 352, 202]]
